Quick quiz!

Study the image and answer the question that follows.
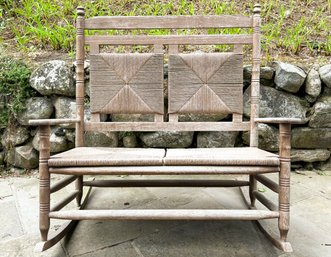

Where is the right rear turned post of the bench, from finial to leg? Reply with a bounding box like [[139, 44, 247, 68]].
[[249, 4, 261, 207]]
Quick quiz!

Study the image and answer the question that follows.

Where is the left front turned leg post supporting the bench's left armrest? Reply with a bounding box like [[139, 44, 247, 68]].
[[39, 125, 51, 241]]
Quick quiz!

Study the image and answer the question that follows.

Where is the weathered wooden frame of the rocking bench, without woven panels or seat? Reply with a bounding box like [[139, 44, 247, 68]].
[[30, 5, 302, 252]]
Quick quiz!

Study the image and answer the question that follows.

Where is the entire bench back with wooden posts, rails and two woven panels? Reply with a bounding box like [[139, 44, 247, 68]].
[[76, 5, 261, 147]]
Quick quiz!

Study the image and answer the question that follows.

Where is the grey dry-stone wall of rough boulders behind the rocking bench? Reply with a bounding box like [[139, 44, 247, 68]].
[[0, 61, 331, 170]]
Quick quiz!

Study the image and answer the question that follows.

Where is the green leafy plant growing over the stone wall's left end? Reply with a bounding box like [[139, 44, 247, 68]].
[[0, 57, 34, 127]]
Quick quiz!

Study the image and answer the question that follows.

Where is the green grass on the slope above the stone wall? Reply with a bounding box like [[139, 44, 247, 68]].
[[0, 0, 331, 56]]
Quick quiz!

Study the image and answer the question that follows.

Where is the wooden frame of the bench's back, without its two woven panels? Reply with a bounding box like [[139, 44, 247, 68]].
[[76, 6, 260, 146]]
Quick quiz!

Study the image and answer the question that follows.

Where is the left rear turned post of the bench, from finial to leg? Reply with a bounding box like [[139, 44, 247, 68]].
[[76, 7, 85, 205]]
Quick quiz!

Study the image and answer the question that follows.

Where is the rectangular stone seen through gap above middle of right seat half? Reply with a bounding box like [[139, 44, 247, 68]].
[[197, 131, 239, 148]]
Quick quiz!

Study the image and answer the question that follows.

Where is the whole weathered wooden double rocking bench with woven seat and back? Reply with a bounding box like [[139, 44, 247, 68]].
[[30, 5, 300, 251]]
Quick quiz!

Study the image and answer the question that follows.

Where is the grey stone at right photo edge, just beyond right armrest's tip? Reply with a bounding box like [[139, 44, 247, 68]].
[[309, 96, 331, 127]]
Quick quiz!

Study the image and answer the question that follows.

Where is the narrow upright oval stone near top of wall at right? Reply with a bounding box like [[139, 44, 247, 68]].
[[305, 65, 322, 103]]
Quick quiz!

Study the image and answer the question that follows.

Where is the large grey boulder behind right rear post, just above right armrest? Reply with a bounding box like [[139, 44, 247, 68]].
[[244, 86, 309, 119]]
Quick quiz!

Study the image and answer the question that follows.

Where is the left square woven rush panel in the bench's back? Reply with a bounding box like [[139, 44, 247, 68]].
[[90, 54, 164, 114]]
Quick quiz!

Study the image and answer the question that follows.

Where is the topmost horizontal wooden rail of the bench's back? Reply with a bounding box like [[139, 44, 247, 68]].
[[85, 15, 252, 30]]
